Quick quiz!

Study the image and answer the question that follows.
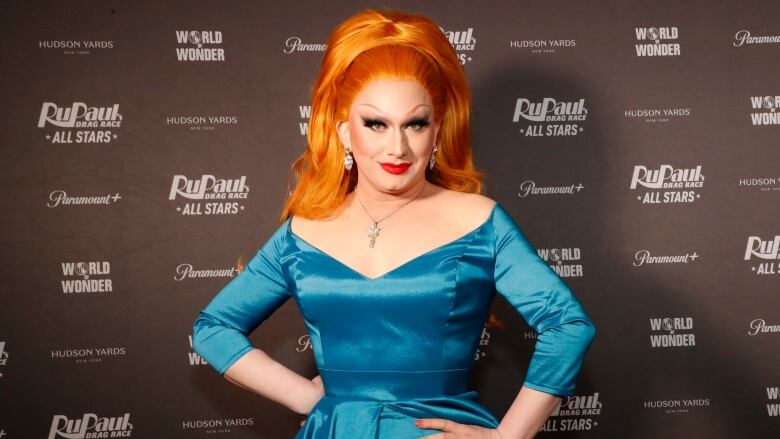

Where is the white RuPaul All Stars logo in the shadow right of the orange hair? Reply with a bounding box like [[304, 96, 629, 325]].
[[512, 98, 588, 137]]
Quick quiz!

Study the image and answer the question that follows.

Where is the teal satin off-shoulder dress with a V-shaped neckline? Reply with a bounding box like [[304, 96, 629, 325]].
[[193, 204, 595, 439]]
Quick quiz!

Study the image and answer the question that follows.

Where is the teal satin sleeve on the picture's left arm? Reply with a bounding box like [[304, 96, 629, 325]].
[[192, 222, 291, 375]]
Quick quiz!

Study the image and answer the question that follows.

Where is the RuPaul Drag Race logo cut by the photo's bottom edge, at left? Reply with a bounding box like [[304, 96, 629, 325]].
[[47, 413, 133, 439]]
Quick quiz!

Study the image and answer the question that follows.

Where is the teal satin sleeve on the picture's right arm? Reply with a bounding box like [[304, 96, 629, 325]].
[[494, 206, 596, 396]]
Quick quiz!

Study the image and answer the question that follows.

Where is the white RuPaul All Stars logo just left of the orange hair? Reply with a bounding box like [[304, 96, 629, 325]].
[[168, 175, 249, 215]]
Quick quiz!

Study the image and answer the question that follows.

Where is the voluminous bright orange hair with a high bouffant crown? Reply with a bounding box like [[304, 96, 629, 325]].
[[280, 9, 484, 222]]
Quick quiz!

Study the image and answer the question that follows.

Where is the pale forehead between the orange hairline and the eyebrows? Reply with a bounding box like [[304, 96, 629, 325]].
[[352, 79, 431, 112]]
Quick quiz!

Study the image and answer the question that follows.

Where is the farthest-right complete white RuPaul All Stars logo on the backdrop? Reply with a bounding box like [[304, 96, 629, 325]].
[[629, 165, 704, 204]]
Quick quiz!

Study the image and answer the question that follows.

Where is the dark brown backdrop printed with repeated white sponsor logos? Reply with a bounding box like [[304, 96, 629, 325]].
[[0, 0, 780, 439]]
